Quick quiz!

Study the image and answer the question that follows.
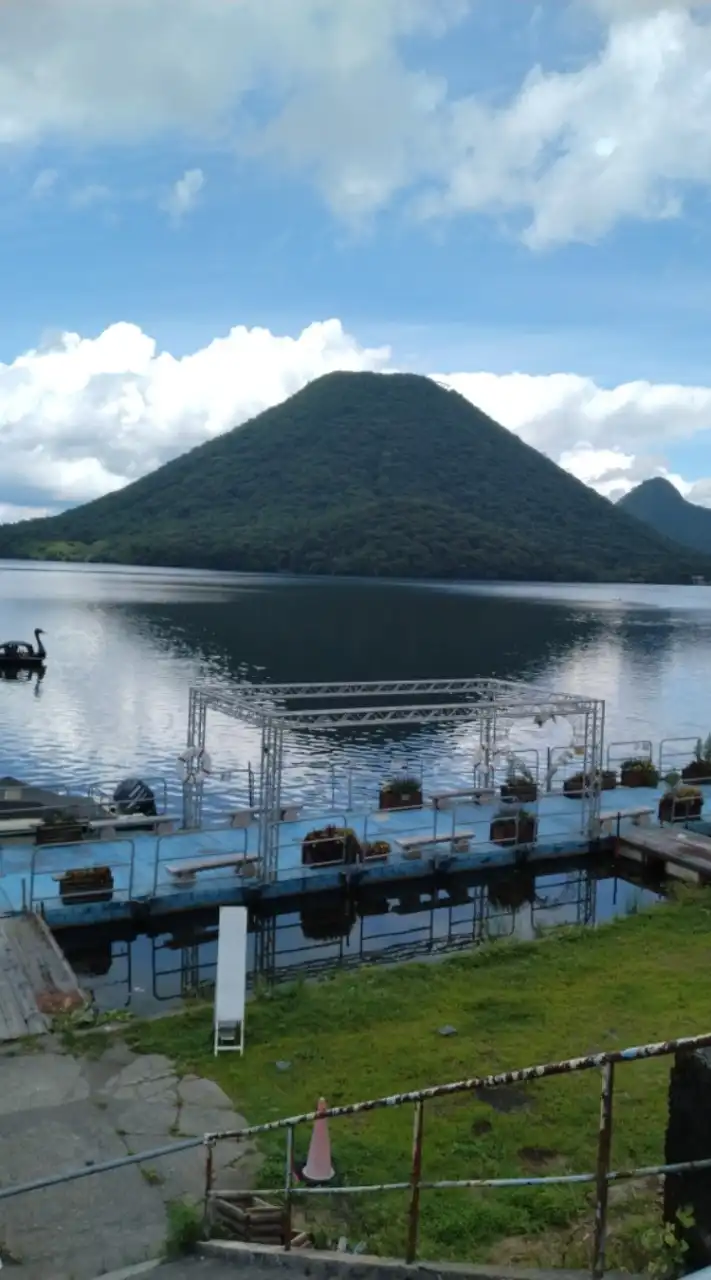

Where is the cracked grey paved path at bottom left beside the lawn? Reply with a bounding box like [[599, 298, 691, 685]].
[[0, 1037, 259, 1280]]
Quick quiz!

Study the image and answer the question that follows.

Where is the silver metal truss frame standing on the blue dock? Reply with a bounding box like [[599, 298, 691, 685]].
[[183, 678, 605, 879]]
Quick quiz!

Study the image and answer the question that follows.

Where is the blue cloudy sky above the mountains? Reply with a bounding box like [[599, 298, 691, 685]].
[[0, 0, 711, 521]]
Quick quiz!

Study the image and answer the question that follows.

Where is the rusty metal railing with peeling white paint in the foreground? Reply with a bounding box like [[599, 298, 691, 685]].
[[0, 1032, 711, 1280]]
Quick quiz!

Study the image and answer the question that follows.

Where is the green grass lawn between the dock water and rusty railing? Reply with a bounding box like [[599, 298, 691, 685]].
[[127, 893, 711, 1270]]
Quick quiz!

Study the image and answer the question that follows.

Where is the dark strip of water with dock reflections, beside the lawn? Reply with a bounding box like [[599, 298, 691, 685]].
[[58, 859, 661, 1015]]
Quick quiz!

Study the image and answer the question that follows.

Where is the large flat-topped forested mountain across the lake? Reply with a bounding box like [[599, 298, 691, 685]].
[[0, 372, 711, 582]]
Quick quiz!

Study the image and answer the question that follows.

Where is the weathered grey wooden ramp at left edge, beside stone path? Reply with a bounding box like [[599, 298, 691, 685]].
[[0, 915, 86, 1044]]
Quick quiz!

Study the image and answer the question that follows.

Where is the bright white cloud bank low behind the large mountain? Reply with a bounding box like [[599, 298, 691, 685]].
[[0, 320, 711, 520]]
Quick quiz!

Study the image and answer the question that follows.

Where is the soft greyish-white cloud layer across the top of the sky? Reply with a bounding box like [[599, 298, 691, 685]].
[[0, 0, 711, 247]]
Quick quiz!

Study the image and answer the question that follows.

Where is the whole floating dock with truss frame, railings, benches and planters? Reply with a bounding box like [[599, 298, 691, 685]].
[[0, 678, 711, 929]]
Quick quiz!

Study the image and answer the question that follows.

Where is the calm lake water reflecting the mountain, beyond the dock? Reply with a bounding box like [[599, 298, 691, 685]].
[[0, 563, 711, 1004]]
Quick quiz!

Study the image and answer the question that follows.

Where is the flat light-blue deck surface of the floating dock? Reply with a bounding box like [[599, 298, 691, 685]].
[[0, 788, 711, 929]]
